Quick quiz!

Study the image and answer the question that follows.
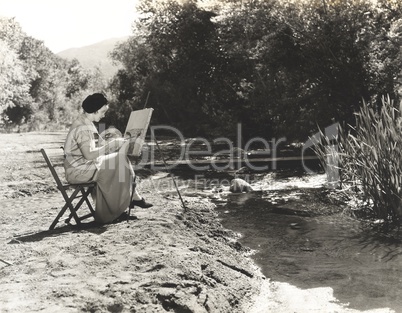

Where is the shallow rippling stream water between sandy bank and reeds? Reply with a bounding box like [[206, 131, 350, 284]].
[[207, 175, 402, 312]]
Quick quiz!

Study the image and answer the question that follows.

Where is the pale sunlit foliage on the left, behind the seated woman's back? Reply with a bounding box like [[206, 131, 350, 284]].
[[0, 18, 104, 131]]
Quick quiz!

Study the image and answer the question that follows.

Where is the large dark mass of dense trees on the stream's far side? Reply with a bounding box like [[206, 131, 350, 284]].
[[111, 0, 402, 140]]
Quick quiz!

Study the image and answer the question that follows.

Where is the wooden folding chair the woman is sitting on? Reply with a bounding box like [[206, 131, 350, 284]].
[[40, 149, 96, 229]]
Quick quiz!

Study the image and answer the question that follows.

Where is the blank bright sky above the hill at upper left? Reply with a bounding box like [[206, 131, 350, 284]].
[[0, 0, 138, 53]]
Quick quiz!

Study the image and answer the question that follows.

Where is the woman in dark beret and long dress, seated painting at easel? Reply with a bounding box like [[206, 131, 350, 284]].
[[64, 93, 152, 223]]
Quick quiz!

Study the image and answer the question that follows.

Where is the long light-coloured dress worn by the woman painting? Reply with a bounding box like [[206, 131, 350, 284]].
[[64, 116, 134, 223]]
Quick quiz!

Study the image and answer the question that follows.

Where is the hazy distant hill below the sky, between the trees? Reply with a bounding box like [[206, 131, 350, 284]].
[[57, 37, 128, 79]]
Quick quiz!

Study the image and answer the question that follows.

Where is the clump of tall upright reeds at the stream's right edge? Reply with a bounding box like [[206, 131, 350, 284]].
[[314, 96, 402, 229]]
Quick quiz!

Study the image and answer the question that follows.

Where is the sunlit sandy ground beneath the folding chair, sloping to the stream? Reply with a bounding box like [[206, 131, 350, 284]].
[[0, 133, 396, 313]]
